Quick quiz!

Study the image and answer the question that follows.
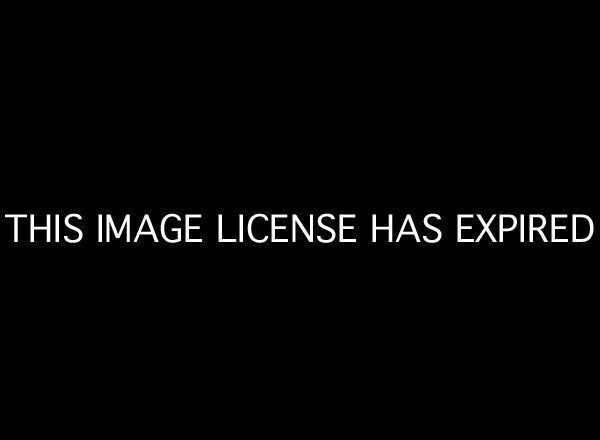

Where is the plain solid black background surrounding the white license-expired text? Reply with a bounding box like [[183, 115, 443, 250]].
[[1, 5, 598, 433]]
